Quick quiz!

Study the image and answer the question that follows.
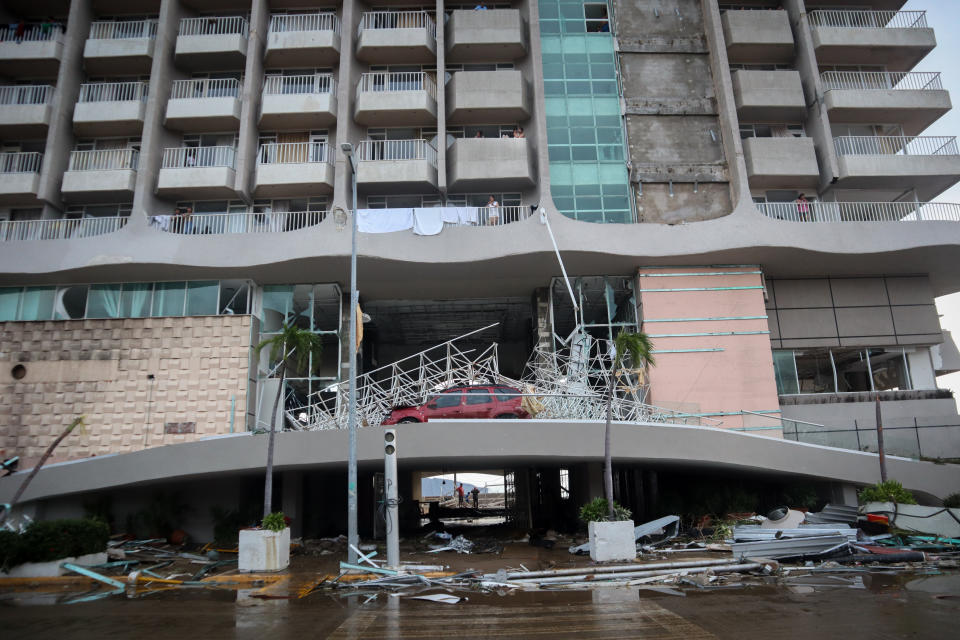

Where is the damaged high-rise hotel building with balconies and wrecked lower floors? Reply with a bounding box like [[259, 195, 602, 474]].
[[0, 0, 960, 538]]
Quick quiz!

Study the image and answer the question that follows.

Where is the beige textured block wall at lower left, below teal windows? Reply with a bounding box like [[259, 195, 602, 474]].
[[0, 316, 250, 466]]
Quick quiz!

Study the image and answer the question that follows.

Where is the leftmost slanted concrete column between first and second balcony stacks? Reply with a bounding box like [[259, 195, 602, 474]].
[[37, 0, 93, 218]]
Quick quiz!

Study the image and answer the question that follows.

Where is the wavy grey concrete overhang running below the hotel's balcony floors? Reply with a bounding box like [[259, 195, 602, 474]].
[[0, 207, 960, 299]]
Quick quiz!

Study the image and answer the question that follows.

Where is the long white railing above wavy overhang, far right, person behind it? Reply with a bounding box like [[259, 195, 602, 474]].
[[757, 202, 960, 222]]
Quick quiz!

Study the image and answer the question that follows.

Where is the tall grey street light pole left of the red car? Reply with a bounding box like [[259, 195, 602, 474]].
[[340, 142, 360, 564]]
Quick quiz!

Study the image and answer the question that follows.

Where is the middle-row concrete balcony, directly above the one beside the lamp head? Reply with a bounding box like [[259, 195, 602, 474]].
[[353, 72, 437, 127]]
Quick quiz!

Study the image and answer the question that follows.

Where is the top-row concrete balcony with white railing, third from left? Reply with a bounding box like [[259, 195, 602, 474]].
[[174, 16, 250, 70]]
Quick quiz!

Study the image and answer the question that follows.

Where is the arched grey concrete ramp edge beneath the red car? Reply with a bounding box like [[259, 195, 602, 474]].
[[0, 420, 960, 502]]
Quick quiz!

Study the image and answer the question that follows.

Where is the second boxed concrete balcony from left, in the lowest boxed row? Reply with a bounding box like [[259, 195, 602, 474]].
[[60, 149, 140, 202]]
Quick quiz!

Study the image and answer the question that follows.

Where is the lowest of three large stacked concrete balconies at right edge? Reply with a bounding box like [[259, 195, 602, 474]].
[[834, 136, 960, 200]]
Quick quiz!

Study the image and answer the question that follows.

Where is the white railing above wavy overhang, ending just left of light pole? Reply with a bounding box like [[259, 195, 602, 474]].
[[150, 211, 327, 235]]
